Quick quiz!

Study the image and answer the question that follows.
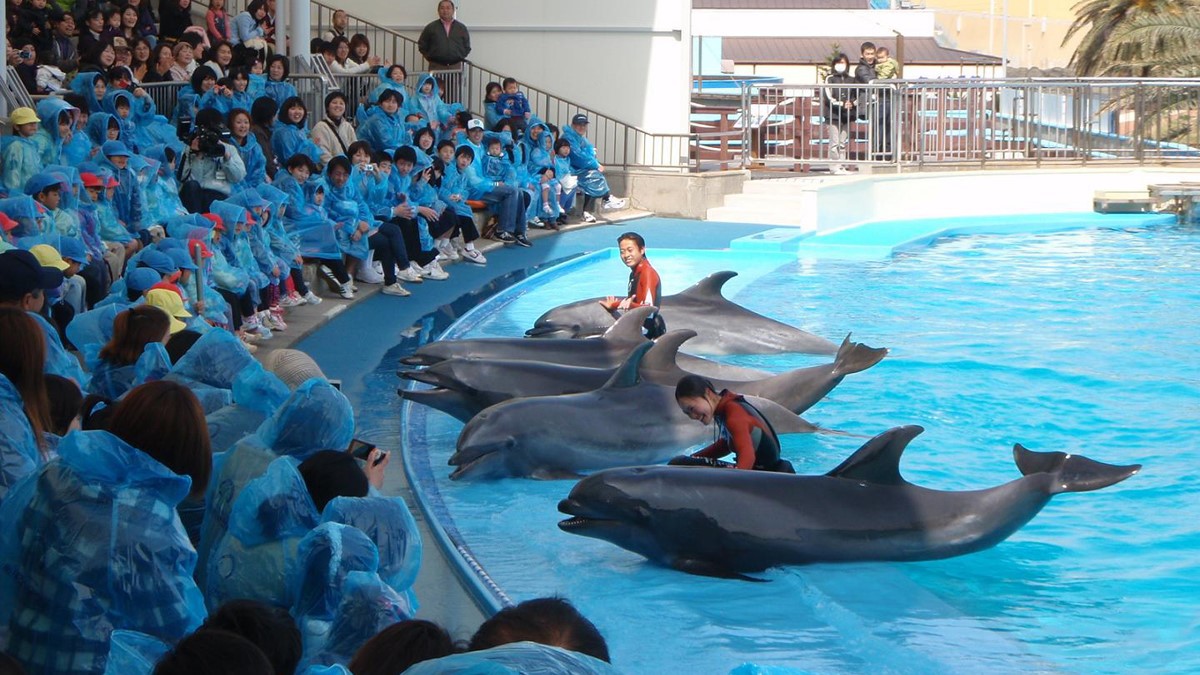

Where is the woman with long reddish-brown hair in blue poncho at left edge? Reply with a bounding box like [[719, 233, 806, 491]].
[[0, 307, 53, 502]]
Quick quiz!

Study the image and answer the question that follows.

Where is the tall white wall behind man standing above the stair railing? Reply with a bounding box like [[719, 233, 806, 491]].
[[337, 0, 691, 133]]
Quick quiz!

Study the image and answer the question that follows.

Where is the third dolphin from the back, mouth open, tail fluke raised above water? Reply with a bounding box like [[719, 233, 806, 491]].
[[400, 330, 887, 422]]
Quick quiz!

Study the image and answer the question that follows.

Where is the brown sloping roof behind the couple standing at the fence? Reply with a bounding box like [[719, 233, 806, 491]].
[[721, 35, 1002, 66]]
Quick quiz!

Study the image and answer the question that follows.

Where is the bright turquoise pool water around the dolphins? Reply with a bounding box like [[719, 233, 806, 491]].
[[395, 228, 1200, 673]]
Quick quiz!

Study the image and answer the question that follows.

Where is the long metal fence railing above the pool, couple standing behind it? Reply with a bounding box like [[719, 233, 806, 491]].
[[734, 78, 1200, 171]]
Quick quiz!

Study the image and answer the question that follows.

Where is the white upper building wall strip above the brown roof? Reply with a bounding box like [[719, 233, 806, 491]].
[[691, 10, 935, 37]]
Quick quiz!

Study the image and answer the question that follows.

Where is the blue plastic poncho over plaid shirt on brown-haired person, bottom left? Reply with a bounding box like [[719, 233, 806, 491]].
[[0, 431, 205, 673]]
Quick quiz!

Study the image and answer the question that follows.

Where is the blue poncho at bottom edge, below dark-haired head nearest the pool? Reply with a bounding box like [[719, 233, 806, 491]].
[[404, 643, 620, 675]]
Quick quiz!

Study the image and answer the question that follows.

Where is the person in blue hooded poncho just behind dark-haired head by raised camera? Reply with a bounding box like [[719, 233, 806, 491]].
[[197, 378, 354, 586]]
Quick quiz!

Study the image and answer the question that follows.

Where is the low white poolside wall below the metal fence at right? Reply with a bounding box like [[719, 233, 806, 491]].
[[811, 167, 1200, 231]]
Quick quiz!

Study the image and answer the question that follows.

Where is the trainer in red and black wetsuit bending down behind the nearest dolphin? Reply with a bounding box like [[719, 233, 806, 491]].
[[671, 375, 796, 473]]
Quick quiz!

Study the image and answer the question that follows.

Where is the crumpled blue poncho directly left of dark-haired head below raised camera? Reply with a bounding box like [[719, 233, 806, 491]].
[[204, 458, 320, 609]]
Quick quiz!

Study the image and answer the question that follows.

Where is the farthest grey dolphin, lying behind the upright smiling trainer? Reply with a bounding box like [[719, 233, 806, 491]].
[[526, 271, 838, 354]]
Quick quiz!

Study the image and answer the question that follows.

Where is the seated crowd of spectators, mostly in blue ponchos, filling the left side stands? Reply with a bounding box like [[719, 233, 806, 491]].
[[0, 0, 624, 673]]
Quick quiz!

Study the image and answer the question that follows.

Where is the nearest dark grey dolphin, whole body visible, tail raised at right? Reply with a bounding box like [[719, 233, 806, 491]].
[[558, 426, 1141, 578]]
